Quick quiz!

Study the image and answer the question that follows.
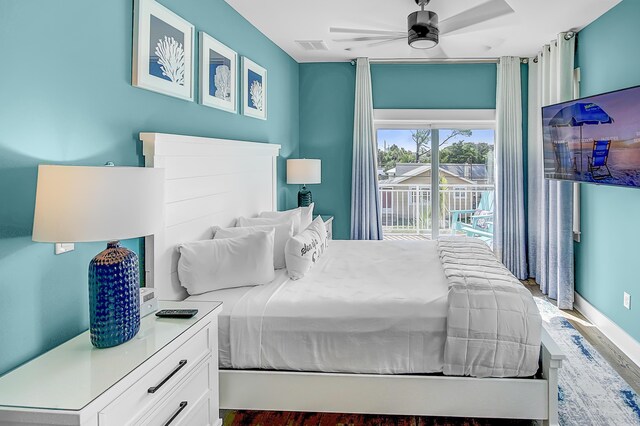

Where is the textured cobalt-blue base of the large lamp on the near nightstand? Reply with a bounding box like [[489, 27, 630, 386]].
[[89, 241, 140, 348]]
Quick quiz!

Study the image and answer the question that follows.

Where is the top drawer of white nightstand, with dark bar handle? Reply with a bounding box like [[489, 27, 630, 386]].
[[100, 325, 210, 426]]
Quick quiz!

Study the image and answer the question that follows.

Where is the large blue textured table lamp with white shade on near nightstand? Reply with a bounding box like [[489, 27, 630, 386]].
[[33, 165, 164, 348]]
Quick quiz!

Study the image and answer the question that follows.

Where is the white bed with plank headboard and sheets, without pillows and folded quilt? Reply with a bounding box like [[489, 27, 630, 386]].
[[140, 133, 563, 424]]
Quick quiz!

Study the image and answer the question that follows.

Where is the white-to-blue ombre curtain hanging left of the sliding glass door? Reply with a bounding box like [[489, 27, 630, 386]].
[[351, 58, 382, 240]]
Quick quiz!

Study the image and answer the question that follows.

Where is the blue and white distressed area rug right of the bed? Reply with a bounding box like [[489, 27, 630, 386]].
[[536, 298, 640, 426]]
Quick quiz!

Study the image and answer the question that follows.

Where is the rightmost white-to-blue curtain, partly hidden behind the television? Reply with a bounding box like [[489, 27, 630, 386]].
[[528, 33, 575, 309]]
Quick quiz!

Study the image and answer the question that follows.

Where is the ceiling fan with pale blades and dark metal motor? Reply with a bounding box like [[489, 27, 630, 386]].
[[329, 0, 514, 55]]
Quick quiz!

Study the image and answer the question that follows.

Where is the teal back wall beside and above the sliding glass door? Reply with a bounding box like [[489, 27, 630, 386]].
[[300, 63, 496, 239]]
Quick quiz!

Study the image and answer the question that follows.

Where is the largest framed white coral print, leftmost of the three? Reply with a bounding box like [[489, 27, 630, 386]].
[[131, 0, 195, 101]]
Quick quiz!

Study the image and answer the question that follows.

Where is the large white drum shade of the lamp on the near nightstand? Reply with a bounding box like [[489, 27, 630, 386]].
[[33, 165, 164, 243]]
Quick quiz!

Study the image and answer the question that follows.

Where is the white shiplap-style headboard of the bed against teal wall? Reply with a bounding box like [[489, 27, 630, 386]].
[[140, 133, 280, 300]]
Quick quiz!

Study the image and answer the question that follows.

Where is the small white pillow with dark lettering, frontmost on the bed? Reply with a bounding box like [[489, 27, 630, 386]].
[[284, 219, 327, 280]]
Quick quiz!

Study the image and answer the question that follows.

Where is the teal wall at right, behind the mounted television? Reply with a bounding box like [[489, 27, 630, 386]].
[[575, 0, 640, 340]]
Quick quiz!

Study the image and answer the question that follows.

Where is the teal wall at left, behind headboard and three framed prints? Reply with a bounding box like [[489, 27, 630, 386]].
[[0, 0, 299, 374]]
